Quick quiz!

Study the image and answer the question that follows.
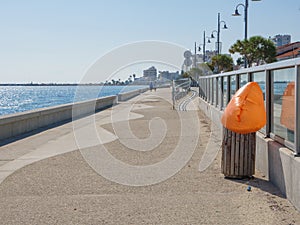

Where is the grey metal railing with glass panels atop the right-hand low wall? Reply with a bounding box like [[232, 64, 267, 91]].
[[199, 58, 300, 156]]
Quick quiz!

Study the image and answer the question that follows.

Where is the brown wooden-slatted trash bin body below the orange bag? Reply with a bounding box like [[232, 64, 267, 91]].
[[221, 127, 256, 179]]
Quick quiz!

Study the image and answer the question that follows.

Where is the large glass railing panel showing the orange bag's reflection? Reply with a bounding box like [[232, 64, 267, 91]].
[[271, 68, 295, 143]]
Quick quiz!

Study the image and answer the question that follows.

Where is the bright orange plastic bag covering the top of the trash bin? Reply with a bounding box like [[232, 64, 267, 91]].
[[221, 82, 267, 134]]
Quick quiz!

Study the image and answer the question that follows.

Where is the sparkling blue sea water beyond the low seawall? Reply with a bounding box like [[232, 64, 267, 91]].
[[0, 86, 145, 115]]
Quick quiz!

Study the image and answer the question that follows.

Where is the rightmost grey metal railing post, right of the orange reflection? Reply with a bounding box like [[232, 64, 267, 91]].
[[294, 65, 300, 157]]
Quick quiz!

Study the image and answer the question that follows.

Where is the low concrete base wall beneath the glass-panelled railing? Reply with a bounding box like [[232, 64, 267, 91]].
[[199, 98, 300, 211]]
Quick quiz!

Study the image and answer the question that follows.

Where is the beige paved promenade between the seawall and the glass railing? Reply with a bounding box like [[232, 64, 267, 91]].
[[0, 88, 300, 225]]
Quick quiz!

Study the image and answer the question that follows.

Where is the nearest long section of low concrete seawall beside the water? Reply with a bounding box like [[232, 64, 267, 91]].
[[0, 96, 117, 141]]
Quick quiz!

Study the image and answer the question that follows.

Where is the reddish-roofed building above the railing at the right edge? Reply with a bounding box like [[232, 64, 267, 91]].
[[276, 41, 300, 61]]
